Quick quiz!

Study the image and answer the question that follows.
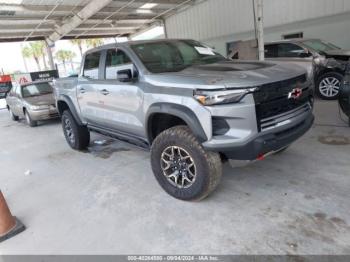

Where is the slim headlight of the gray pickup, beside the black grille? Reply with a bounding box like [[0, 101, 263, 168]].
[[194, 87, 257, 106]]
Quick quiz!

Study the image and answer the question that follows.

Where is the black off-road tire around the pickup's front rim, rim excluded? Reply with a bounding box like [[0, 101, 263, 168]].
[[151, 126, 222, 201]]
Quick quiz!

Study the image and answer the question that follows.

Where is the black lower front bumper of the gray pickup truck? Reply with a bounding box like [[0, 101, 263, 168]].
[[202, 112, 314, 160]]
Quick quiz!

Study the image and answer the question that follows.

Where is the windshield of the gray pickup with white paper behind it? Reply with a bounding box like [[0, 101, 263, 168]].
[[131, 40, 226, 73]]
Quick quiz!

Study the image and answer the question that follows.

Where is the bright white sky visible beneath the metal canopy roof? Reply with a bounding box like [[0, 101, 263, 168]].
[[0, 26, 164, 74]]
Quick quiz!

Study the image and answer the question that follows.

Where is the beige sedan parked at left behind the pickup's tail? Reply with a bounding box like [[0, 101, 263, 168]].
[[6, 81, 59, 127]]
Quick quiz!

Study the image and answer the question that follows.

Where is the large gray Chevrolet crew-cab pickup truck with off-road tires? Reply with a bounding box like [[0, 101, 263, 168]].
[[55, 40, 314, 200]]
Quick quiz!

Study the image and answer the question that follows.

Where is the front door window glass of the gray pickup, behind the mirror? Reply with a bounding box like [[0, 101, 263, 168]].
[[106, 49, 133, 79]]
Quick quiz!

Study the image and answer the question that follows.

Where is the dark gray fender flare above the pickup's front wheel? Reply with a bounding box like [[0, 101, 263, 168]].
[[146, 102, 208, 144]]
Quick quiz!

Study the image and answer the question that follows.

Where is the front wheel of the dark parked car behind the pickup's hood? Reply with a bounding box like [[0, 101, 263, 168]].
[[316, 72, 343, 100]]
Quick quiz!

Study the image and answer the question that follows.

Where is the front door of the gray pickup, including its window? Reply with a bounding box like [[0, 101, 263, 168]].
[[97, 48, 144, 136]]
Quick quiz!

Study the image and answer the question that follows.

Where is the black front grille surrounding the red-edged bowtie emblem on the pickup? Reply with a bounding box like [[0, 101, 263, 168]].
[[253, 75, 310, 131]]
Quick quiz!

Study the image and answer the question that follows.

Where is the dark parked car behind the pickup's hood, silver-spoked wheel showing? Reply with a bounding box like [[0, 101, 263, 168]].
[[265, 39, 350, 100]]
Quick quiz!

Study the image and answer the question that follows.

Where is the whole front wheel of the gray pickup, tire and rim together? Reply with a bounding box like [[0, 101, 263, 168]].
[[151, 126, 222, 201]]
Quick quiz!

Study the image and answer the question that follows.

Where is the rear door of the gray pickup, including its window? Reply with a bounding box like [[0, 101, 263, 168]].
[[77, 51, 103, 125]]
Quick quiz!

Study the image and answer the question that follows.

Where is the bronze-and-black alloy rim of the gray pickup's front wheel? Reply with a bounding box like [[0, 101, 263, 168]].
[[160, 146, 196, 188]]
